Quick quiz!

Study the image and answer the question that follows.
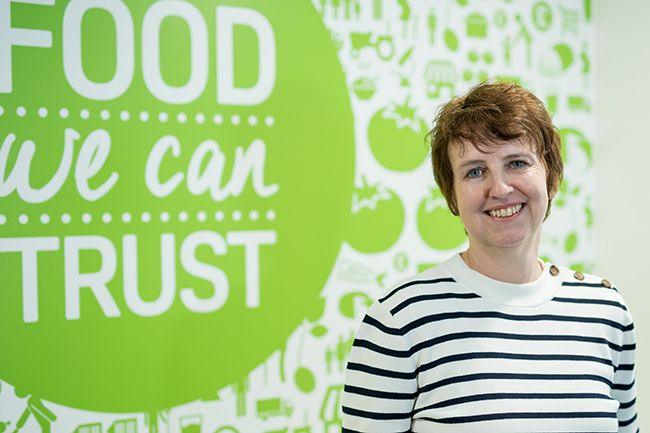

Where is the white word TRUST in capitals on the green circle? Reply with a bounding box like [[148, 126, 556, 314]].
[[0, 230, 270, 323]]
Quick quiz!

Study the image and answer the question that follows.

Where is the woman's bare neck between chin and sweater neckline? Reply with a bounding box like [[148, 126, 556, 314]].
[[461, 243, 544, 284]]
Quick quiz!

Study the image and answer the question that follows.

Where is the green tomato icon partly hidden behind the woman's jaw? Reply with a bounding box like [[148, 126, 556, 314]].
[[417, 188, 467, 250]]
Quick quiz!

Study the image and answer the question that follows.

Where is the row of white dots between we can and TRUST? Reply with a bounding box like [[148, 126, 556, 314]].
[[0, 209, 276, 225]]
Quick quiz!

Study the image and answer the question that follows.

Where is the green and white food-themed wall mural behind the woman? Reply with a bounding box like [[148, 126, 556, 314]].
[[0, 0, 595, 433]]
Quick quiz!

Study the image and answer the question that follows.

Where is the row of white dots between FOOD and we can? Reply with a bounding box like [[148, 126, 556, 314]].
[[0, 106, 275, 128]]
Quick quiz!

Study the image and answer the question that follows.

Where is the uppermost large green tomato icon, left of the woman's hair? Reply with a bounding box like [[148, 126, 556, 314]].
[[368, 98, 427, 171]]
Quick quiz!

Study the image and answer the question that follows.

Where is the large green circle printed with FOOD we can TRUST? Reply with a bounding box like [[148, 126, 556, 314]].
[[0, 0, 354, 412]]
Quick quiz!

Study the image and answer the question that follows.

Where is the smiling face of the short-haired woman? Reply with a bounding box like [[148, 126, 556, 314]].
[[449, 139, 548, 249]]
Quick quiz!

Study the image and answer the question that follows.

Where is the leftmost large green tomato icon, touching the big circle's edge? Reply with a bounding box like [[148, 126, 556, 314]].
[[347, 178, 404, 253]]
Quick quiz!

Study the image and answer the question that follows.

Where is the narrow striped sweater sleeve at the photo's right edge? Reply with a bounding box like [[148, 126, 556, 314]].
[[612, 310, 639, 433]]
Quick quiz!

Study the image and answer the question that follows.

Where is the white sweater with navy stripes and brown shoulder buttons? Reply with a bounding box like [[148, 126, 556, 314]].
[[342, 254, 639, 433]]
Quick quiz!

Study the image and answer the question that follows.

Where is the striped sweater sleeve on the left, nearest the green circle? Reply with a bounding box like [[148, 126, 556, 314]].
[[341, 301, 418, 433]]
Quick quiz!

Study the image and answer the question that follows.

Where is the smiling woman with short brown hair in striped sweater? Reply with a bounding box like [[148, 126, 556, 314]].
[[342, 83, 638, 433]]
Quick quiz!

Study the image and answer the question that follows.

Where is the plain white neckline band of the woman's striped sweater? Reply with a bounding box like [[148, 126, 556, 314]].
[[440, 253, 562, 307]]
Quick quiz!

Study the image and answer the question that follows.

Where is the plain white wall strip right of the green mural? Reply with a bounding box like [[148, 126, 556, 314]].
[[594, 0, 650, 418]]
